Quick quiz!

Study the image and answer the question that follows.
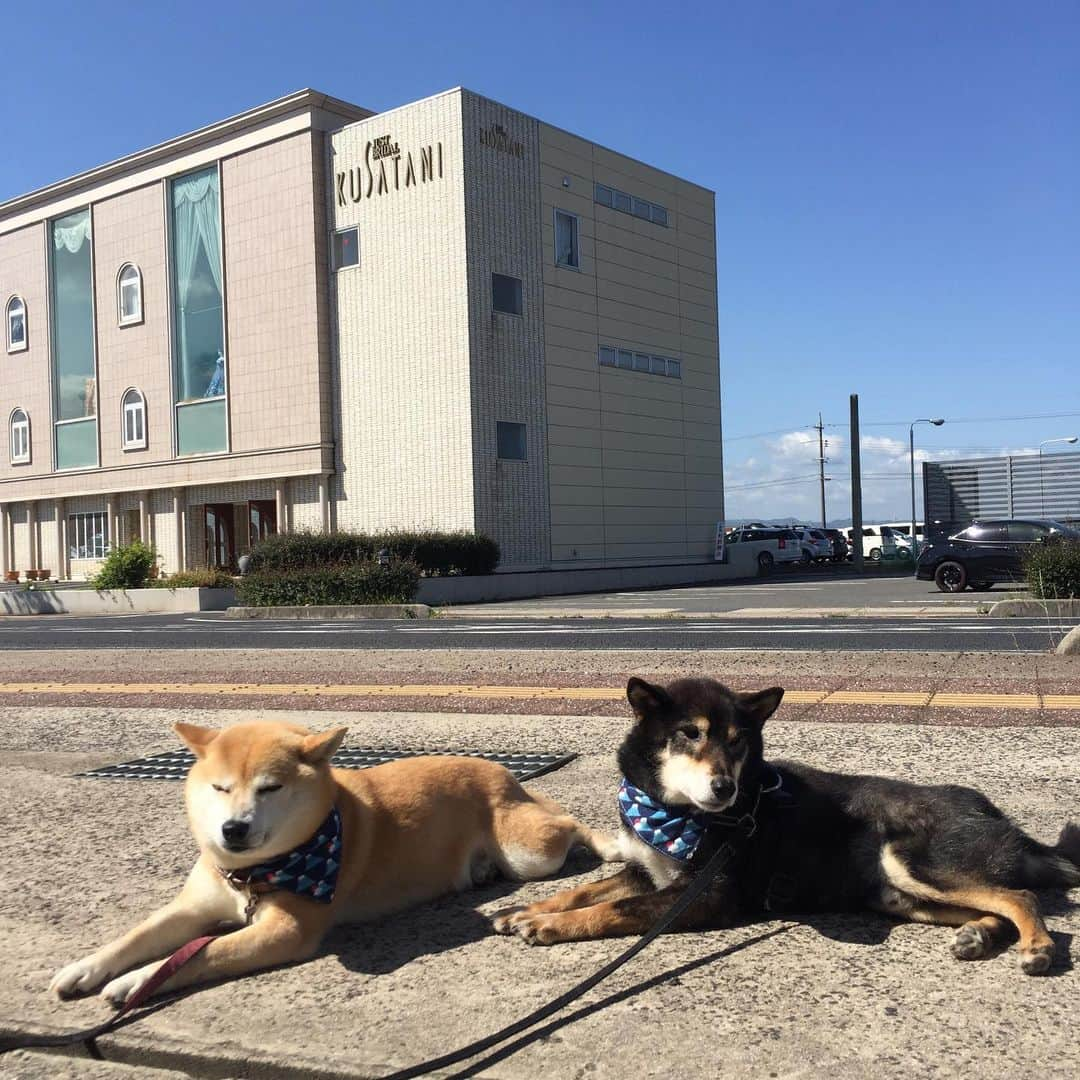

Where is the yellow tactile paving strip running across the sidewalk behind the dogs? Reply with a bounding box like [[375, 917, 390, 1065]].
[[0, 683, 1080, 712]]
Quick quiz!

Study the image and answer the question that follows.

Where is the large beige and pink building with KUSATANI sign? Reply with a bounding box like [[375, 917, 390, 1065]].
[[0, 90, 724, 578]]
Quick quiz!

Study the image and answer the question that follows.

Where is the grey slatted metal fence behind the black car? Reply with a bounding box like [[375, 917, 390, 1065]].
[[922, 451, 1080, 534]]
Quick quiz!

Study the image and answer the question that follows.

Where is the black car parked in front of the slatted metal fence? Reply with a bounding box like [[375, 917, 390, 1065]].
[[915, 517, 1080, 593]]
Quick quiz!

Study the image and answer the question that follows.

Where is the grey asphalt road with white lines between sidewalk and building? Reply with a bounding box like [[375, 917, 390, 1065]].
[[0, 612, 1070, 652]]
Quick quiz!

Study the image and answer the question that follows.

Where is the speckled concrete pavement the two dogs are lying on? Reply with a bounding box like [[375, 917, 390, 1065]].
[[0, 708, 1080, 1080]]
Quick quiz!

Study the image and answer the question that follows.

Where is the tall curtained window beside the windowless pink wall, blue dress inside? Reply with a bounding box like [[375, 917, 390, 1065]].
[[170, 165, 228, 454]]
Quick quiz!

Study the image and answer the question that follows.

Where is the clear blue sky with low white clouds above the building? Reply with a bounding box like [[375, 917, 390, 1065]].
[[0, 0, 1080, 519]]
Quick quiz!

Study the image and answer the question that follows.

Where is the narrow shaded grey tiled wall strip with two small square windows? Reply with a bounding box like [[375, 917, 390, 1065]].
[[462, 92, 551, 568]]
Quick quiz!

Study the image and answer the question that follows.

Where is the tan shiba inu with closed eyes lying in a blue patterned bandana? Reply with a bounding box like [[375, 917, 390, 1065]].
[[50, 721, 618, 1004]]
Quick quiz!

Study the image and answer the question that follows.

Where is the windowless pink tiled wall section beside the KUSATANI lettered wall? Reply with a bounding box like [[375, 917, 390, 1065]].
[[221, 132, 329, 453]]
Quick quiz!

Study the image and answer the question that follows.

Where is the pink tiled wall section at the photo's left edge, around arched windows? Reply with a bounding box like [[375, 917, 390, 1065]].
[[0, 225, 53, 481]]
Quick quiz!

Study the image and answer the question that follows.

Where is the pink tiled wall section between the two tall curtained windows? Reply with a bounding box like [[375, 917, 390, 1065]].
[[94, 184, 173, 468]]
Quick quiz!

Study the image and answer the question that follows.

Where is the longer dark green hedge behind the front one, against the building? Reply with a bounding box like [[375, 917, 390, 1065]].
[[248, 530, 499, 578]]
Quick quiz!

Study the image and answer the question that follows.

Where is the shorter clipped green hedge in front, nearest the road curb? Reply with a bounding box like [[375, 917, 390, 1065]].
[[237, 562, 420, 607]]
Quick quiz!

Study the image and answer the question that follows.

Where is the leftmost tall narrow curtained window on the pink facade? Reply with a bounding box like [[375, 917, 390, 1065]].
[[49, 208, 97, 469]]
